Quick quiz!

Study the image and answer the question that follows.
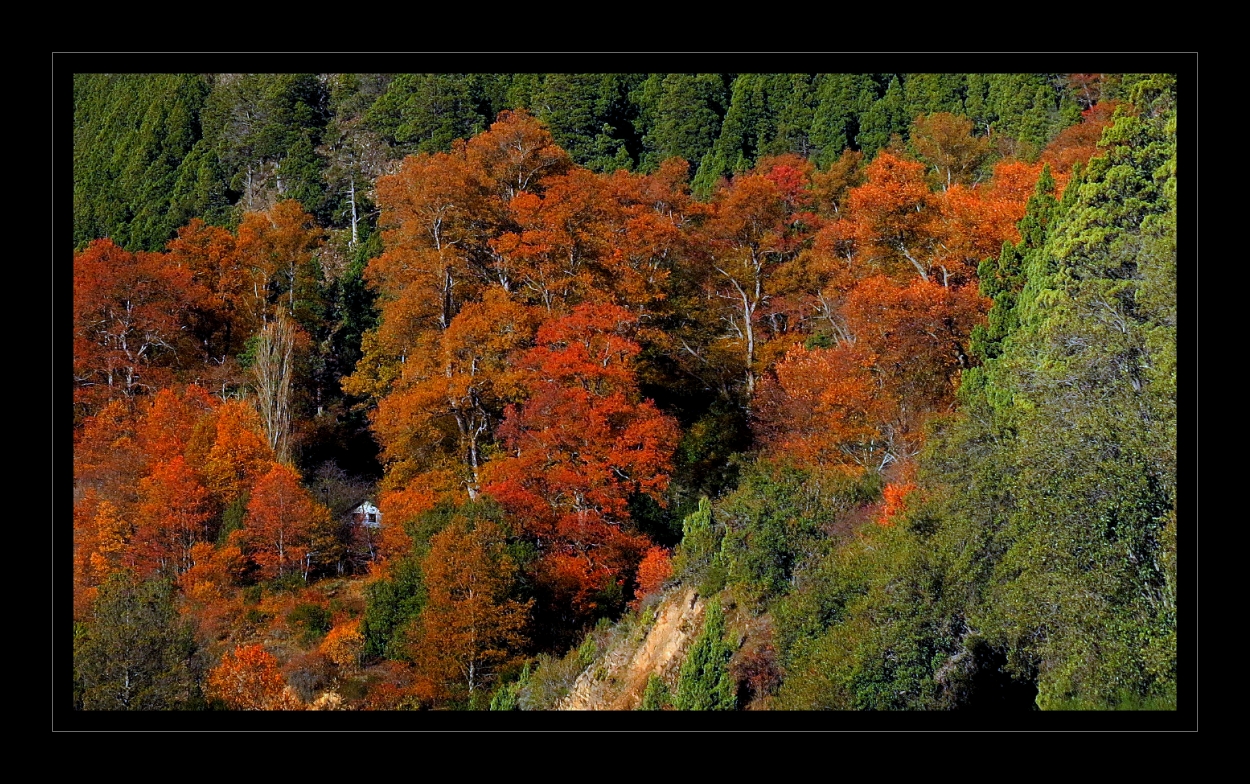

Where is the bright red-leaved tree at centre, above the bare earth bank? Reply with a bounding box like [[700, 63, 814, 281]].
[[486, 305, 678, 623]]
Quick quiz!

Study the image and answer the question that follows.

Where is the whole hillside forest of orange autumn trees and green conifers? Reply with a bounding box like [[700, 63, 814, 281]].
[[68, 73, 1194, 718]]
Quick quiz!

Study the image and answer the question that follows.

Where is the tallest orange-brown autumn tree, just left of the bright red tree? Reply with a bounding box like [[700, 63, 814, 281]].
[[344, 111, 569, 509]]
